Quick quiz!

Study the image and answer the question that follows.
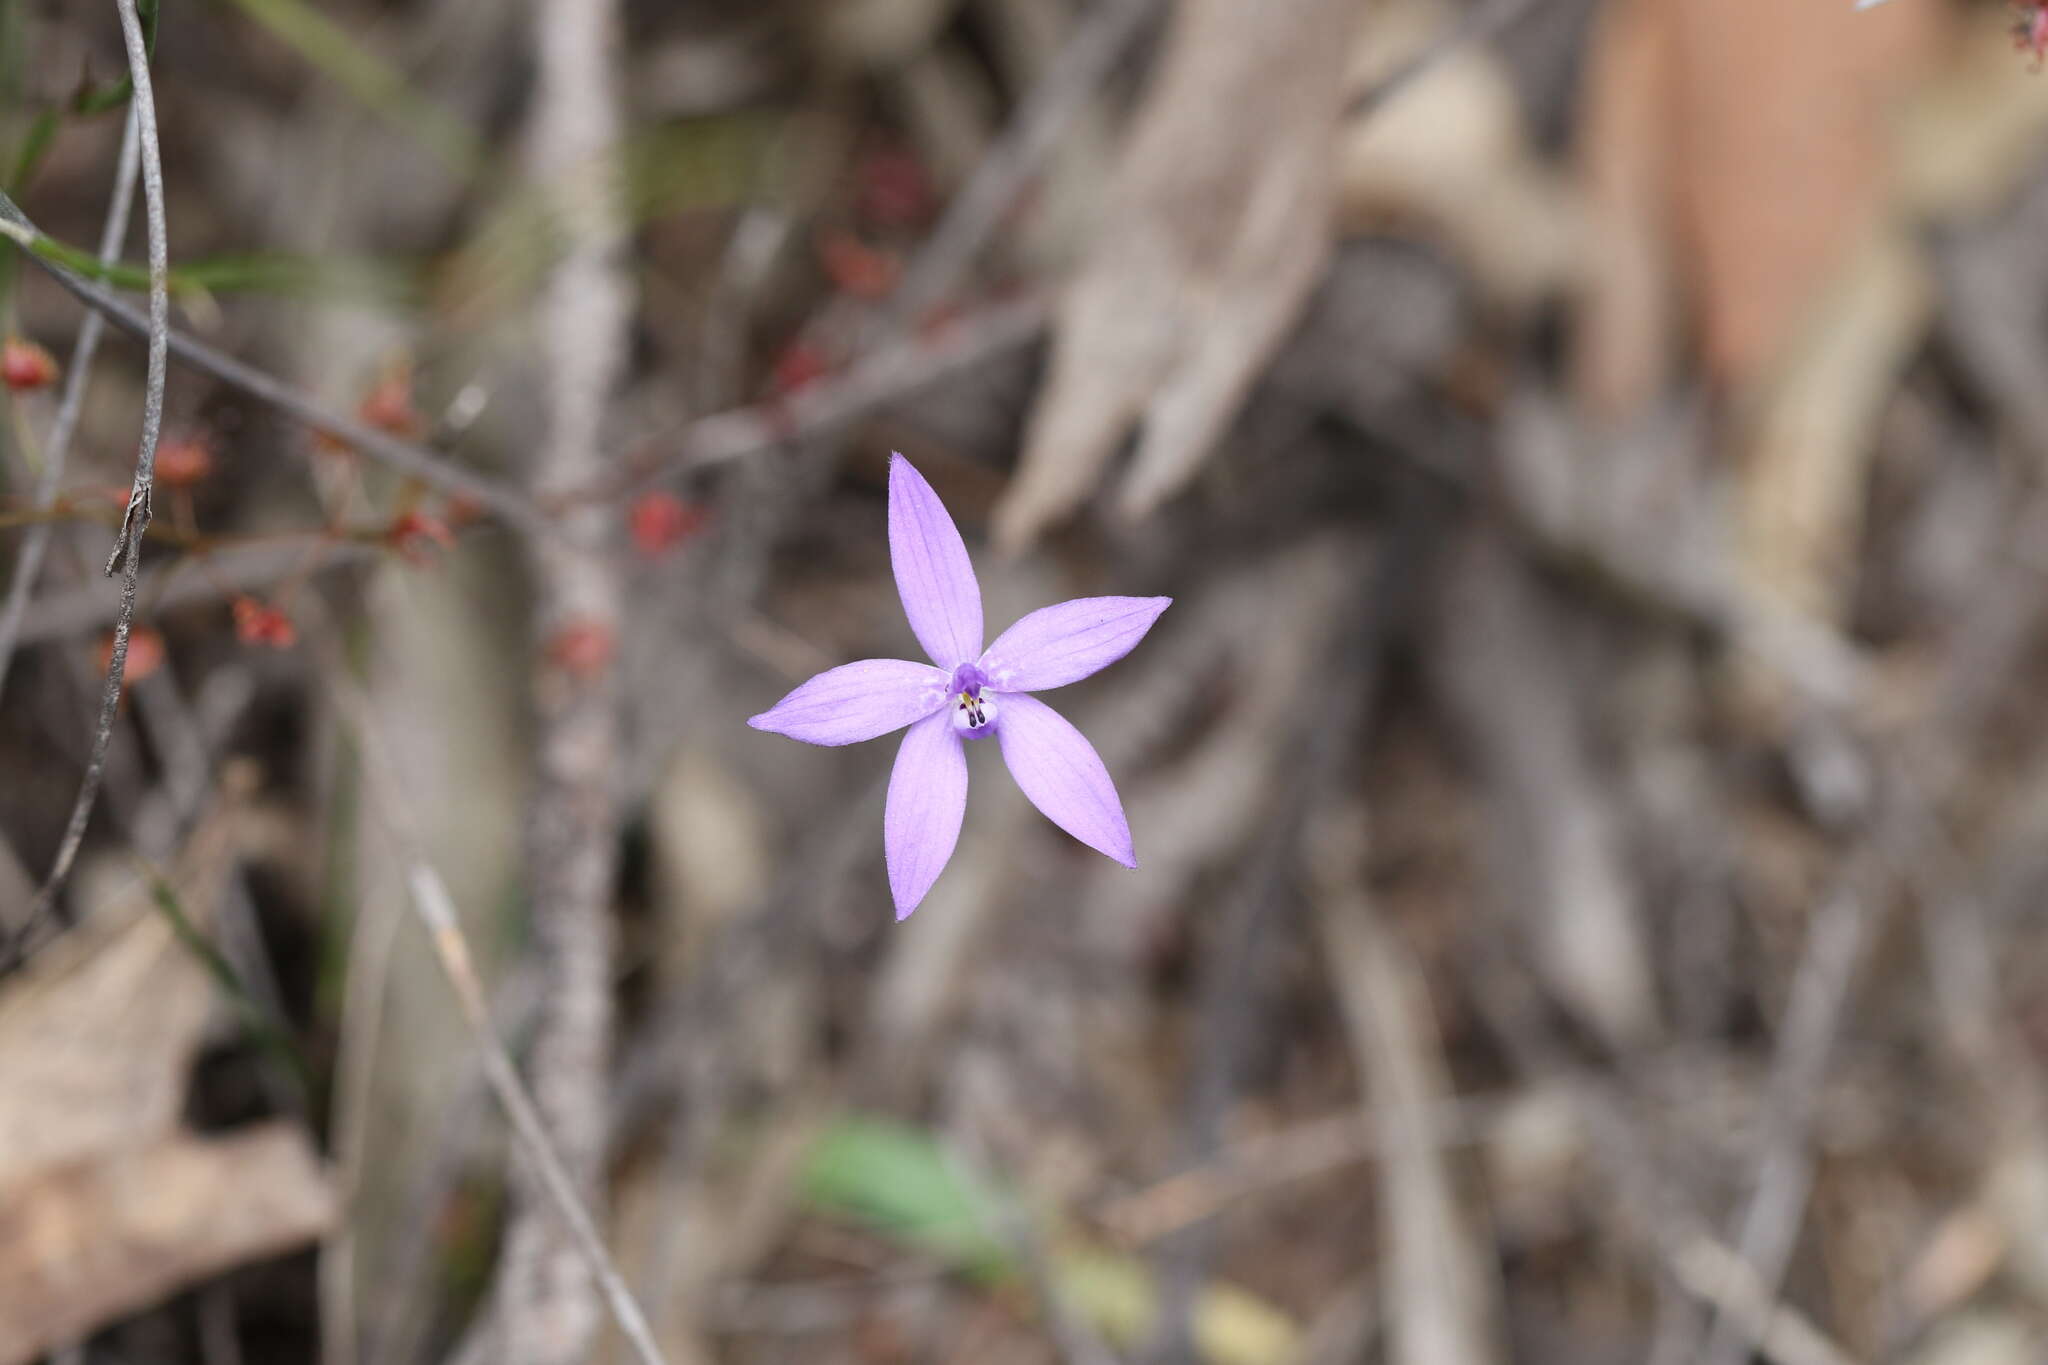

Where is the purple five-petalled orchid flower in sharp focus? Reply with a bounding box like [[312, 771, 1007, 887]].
[[748, 454, 1174, 919]]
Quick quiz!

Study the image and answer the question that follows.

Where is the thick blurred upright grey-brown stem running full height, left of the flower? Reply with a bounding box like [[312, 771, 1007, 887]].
[[469, 0, 633, 1365]]
